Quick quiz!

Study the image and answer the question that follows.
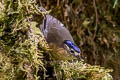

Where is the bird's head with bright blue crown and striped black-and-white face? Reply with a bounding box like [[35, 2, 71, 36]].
[[64, 40, 82, 60]]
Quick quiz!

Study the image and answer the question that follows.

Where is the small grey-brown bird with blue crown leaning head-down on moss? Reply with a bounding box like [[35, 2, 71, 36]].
[[39, 7, 83, 60]]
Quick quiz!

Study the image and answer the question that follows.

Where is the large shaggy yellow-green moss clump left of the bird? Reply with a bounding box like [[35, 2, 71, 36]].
[[0, 0, 47, 80]]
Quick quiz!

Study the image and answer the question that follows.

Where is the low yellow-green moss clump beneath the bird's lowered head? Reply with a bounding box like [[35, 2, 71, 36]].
[[60, 61, 112, 80]]
